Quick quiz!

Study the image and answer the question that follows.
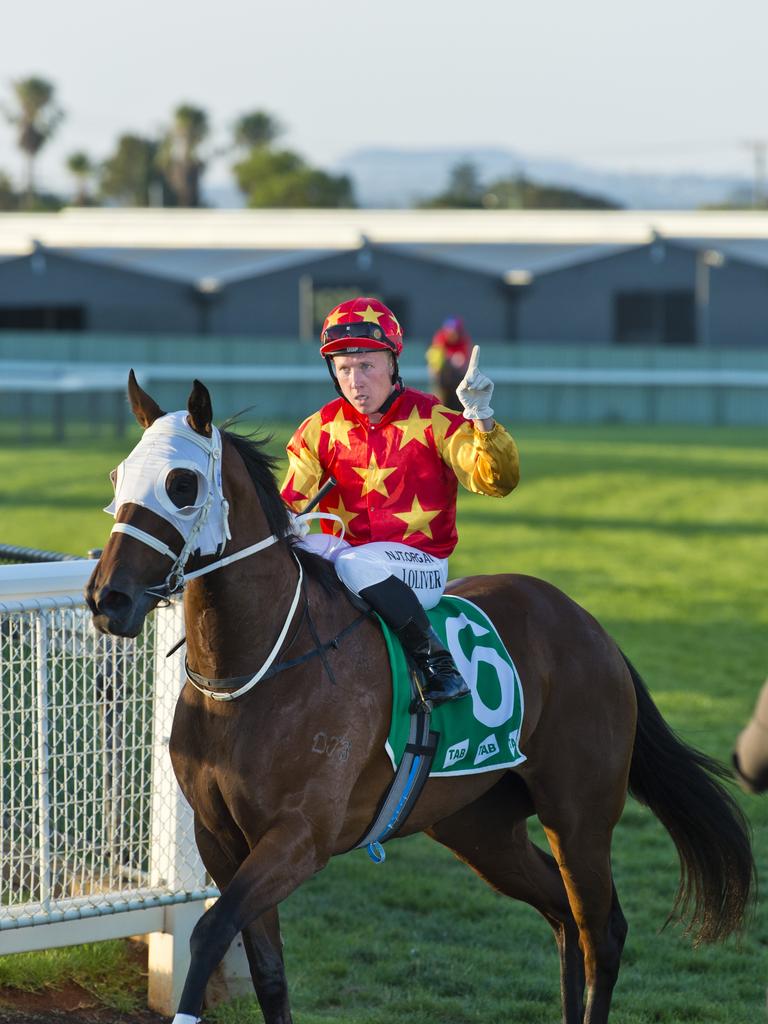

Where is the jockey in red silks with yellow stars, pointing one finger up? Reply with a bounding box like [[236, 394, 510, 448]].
[[282, 298, 519, 705]]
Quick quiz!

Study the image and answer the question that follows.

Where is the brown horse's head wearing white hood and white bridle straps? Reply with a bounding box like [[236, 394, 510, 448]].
[[85, 371, 271, 637]]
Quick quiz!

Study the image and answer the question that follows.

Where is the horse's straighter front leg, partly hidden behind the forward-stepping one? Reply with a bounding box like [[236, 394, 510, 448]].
[[195, 814, 292, 1024]]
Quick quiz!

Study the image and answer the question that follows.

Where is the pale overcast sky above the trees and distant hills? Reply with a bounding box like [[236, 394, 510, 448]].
[[0, 0, 768, 193]]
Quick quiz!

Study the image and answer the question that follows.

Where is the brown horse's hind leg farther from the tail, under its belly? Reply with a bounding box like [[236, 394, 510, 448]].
[[428, 775, 585, 1024]]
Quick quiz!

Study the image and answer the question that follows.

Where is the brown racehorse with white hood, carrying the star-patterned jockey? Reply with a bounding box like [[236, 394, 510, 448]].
[[86, 377, 754, 1024]]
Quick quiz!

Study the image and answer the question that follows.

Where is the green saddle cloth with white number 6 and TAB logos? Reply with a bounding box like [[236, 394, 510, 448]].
[[380, 597, 525, 776]]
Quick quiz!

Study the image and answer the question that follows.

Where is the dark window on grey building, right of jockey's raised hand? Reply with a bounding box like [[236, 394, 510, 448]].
[[613, 289, 696, 345]]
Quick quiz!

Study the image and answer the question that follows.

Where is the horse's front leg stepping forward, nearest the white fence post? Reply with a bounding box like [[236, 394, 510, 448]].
[[173, 818, 328, 1024]]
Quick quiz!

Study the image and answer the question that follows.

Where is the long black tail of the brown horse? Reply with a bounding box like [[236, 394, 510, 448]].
[[623, 654, 756, 943]]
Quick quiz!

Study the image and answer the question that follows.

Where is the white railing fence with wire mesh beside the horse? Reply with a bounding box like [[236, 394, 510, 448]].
[[0, 561, 247, 1014]]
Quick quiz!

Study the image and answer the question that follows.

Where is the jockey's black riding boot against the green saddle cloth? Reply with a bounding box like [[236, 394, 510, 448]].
[[360, 577, 469, 706]]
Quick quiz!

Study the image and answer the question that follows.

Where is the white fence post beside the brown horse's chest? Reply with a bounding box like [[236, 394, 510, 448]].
[[147, 601, 205, 1017]]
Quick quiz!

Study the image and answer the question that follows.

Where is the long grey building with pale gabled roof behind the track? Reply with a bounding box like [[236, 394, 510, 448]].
[[0, 210, 768, 348]]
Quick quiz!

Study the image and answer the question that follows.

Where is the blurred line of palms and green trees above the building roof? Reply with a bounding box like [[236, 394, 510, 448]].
[[0, 76, 616, 211]]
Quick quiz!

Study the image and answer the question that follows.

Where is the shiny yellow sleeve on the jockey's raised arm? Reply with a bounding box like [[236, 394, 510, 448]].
[[432, 406, 520, 498]]
